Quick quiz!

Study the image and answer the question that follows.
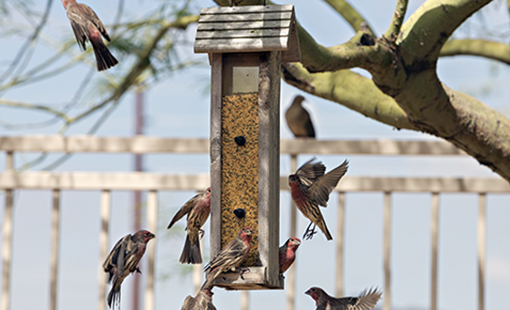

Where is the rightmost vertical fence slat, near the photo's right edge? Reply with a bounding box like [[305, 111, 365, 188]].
[[478, 193, 487, 310]]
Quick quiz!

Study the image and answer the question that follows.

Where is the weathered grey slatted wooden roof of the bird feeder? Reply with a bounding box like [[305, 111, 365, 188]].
[[195, 5, 301, 62]]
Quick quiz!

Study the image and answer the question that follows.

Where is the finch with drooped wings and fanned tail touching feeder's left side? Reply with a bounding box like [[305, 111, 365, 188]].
[[168, 187, 211, 264]]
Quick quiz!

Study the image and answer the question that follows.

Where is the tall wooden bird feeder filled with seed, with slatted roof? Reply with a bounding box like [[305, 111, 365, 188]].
[[195, 5, 300, 290]]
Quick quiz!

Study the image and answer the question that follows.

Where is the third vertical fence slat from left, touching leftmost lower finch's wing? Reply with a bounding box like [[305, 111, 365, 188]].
[[97, 190, 111, 310]]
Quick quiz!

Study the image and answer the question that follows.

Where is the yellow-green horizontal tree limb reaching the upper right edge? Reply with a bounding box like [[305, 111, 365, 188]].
[[439, 39, 510, 65]]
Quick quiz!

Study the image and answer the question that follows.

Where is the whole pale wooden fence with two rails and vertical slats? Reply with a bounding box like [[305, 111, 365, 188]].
[[0, 136, 510, 310]]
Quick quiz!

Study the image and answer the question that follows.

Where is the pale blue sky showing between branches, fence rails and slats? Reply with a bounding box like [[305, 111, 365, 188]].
[[0, 0, 510, 310]]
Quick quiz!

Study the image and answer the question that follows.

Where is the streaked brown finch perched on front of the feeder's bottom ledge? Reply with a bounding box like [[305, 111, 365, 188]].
[[202, 227, 253, 289]]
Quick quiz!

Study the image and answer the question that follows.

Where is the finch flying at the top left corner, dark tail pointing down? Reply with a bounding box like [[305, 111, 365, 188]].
[[62, 0, 119, 71]]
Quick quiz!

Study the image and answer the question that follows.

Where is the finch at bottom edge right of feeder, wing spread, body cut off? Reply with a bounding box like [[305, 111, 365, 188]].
[[305, 287, 382, 310]]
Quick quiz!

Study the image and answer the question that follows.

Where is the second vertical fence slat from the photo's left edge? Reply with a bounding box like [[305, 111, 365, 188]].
[[50, 189, 60, 310]]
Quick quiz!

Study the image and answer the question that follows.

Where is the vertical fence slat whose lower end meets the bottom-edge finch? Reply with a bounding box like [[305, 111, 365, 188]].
[[336, 192, 345, 296]]
